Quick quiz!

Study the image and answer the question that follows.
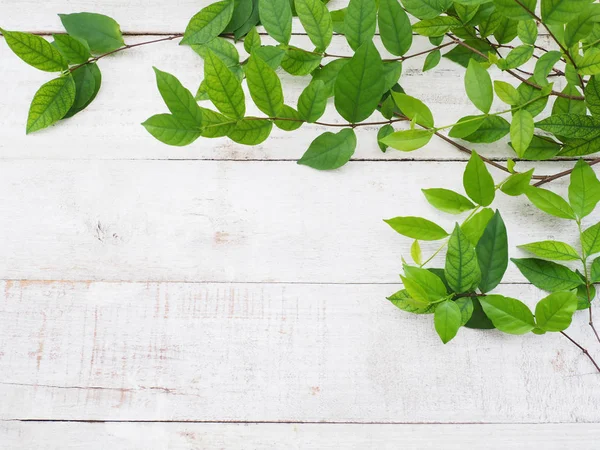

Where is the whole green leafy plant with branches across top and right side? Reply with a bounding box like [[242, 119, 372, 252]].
[[0, 0, 600, 372]]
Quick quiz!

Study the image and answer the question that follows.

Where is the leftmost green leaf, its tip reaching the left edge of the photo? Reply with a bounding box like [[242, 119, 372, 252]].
[[0, 28, 68, 72]]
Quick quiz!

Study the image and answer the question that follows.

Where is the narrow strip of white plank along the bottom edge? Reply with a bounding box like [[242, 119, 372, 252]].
[[0, 422, 600, 450]]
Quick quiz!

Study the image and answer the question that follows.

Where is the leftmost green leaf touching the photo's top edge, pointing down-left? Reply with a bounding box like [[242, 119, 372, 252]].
[[181, 0, 234, 45]]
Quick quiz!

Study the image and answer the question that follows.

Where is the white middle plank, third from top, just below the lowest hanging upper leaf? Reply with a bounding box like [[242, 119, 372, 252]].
[[0, 160, 593, 283]]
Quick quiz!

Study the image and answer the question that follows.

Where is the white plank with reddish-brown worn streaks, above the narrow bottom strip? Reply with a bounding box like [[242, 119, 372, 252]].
[[0, 282, 600, 424]]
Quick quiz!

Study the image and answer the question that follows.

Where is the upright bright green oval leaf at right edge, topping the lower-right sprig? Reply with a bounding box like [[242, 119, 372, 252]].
[[569, 159, 600, 219]]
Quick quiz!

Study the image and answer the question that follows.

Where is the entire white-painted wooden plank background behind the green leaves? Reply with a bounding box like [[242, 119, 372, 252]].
[[0, 0, 600, 450]]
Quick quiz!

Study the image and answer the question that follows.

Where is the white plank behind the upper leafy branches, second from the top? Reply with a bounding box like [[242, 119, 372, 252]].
[[0, 36, 560, 160]]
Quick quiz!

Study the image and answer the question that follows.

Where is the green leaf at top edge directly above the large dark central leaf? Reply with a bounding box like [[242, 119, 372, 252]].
[[344, 0, 377, 51]]
